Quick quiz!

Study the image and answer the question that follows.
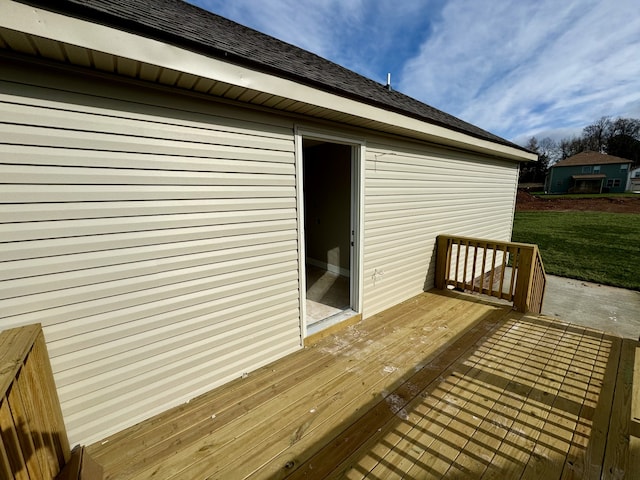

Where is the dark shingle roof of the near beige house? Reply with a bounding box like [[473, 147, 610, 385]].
[[22, 0, 526, 151]]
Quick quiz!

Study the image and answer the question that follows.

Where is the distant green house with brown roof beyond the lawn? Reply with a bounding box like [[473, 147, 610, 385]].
[[545, 152, 632, 193]]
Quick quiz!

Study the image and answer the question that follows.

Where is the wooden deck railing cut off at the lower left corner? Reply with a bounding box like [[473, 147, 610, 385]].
[[0, 325, 70, 480]]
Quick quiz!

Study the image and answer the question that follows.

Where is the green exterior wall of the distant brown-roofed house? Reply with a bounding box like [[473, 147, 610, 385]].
[[546, 163, 629, 193]]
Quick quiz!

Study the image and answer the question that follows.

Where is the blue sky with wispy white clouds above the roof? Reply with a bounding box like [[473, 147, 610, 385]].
[[190, 0, 640, 143]]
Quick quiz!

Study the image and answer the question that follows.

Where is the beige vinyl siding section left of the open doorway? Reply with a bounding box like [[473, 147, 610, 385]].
[[0, 65, 301, 444]]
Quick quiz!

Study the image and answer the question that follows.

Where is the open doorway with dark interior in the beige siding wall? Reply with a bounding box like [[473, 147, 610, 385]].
[[302, 138, 358, 334]]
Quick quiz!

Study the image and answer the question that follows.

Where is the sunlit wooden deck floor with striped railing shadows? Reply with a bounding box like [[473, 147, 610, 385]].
[[89, 291, 640, 480]]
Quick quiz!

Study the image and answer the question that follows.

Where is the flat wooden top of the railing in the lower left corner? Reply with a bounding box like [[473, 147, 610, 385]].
[[0, 324, 42, 395]]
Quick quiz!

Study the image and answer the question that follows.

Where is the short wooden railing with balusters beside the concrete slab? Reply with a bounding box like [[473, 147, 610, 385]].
[[435, 235, 546, 313]]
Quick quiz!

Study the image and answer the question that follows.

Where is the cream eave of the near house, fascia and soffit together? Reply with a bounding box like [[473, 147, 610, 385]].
[[0, 2, 537, 161]]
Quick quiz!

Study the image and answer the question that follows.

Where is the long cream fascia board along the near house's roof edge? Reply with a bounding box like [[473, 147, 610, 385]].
[[0, 0, 537, 161]]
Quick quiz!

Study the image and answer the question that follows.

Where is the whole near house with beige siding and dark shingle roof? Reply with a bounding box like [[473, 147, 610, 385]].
[[0, 0, 536, 443]]
